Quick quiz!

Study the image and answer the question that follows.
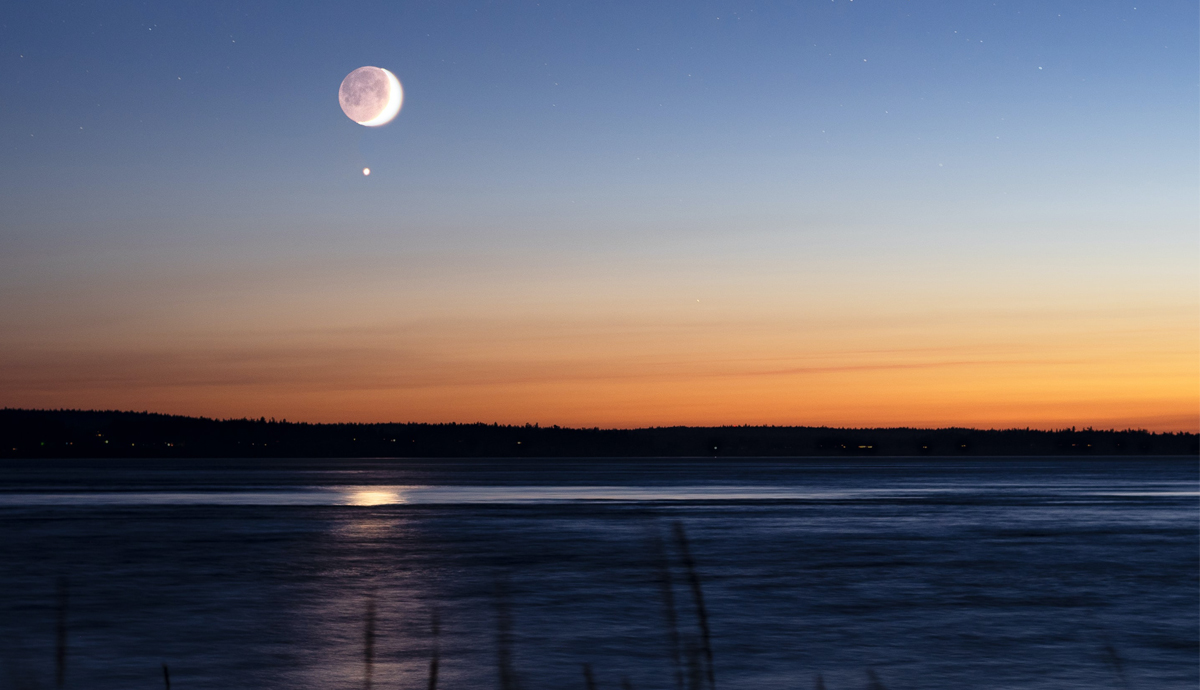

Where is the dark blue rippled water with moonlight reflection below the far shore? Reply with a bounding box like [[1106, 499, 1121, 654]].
[[0, 458, 1200, 690]]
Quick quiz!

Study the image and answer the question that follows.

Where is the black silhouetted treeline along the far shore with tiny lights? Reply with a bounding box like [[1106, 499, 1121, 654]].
[[0, 408, 1200, 458]]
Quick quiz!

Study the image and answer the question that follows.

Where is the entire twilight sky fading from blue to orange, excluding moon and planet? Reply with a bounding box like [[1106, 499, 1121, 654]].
[[0, 0, 1200, 431]]
